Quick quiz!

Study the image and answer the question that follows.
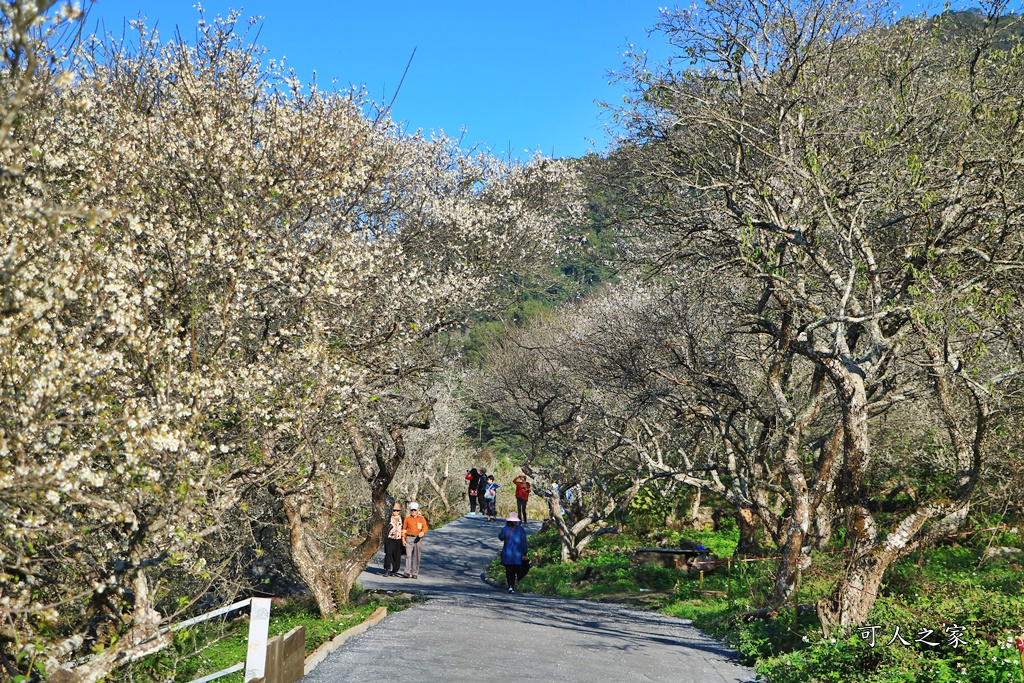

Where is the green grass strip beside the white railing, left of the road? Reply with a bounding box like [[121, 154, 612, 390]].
[[110, 599, 409, 683]]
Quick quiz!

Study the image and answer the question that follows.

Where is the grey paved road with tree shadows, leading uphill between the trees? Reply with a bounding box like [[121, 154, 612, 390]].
[[303, 517, 755, 683]]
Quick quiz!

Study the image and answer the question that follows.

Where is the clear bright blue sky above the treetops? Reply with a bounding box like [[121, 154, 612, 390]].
[[85, 0, 679, 159]]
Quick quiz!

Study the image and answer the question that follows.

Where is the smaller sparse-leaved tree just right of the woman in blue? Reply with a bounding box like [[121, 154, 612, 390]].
[[474, 299, 671, 561]]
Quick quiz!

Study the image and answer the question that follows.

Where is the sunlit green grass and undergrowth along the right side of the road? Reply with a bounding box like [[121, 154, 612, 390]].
[[501, 530, 1024, 683]]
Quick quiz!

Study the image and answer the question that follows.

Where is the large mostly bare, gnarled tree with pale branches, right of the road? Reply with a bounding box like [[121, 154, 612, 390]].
[[614, 0, 1024, 631]]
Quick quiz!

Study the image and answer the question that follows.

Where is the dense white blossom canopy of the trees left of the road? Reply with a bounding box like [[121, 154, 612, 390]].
[[0, 3, 577, 680]]
